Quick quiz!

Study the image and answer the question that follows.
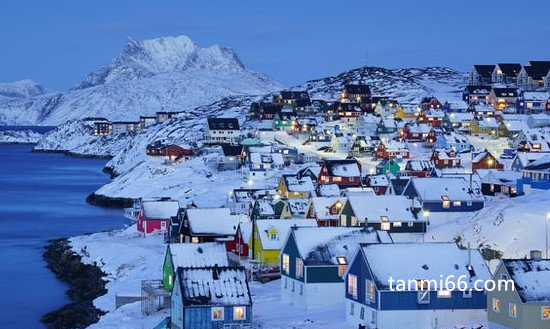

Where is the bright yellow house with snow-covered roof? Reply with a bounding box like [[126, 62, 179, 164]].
[[248, 219, 317, 266]]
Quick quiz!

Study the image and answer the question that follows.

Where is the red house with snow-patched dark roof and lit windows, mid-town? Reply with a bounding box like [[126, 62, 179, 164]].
[[318, 159, 361, 188]]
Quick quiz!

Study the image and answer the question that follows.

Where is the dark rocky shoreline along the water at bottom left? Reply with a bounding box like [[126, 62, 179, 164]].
[[41, 238, 107, 329]]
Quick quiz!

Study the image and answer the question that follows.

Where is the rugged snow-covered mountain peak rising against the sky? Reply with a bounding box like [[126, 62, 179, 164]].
[[75, 35, 244, 89]]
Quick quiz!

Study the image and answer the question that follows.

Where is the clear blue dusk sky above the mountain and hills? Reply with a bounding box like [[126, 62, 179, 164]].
[[0, 0, 550, 91]]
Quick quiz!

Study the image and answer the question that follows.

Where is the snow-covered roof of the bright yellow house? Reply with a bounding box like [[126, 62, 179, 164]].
[[256, 219, 317, 250]]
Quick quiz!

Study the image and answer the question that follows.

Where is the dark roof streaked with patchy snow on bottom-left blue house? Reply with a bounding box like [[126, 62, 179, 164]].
[[177, 266, 252, 306]]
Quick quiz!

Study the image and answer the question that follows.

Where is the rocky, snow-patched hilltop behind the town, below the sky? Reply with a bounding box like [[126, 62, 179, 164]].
[[300, 67, 467, 104]]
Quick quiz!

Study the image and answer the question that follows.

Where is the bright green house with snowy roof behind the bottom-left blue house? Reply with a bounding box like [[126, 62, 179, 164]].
[[162, 242, 229, 291]]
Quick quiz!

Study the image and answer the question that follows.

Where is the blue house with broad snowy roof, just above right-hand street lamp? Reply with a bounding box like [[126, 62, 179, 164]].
[[403, 177, 485, 212]]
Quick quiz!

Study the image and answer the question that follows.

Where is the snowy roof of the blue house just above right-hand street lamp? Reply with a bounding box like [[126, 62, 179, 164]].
[[412, 177, 484, 201]]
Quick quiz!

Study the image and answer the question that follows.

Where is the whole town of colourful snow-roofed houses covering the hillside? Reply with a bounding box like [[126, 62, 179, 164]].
[[68, 61, 550, 329]]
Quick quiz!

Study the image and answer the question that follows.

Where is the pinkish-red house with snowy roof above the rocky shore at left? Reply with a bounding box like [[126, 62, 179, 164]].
[[137, 200, 180, 234]]
